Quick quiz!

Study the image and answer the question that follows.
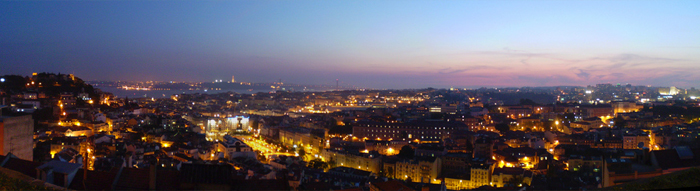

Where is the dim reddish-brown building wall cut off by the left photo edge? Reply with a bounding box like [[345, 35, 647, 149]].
[[0, 113, 34, 161]]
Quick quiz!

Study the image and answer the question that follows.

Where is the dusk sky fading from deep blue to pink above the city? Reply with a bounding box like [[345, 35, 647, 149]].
[[0, 0, 700, 88]]
